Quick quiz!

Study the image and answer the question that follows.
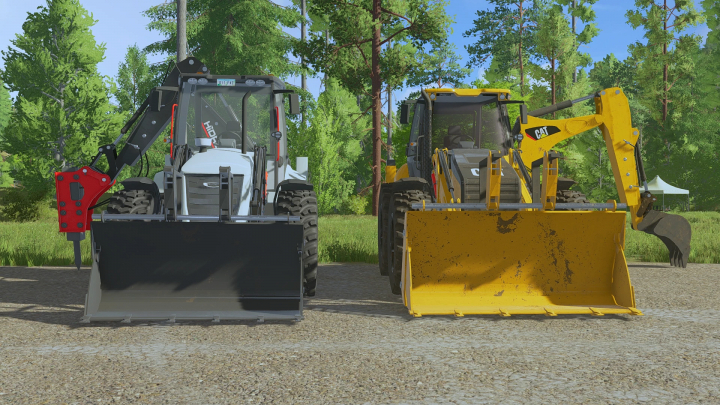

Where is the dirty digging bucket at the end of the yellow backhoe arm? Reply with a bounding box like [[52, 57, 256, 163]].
[[638, 210, 692, 268]]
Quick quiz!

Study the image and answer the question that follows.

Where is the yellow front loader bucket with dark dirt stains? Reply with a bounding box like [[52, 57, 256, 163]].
[[402, 211, 642, 316]]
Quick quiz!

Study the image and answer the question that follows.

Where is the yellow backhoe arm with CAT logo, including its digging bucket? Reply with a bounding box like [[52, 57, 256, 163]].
[[519, 87, 691, 267]]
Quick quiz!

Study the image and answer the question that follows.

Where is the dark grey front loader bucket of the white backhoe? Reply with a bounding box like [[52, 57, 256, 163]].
[[82, 221, 303, 322]]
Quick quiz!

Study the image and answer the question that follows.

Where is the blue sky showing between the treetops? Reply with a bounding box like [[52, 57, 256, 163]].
[[0, 0, 708, 100]]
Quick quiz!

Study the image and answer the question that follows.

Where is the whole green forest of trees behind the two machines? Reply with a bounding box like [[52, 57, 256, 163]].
[[0, 0, 720, 221]]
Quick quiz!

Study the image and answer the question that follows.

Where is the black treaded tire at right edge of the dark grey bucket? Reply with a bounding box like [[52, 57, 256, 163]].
[[275, 189, 318, 297]]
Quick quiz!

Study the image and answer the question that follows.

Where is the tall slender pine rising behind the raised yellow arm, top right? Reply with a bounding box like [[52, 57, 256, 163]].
[[625, 0, 702, 126]]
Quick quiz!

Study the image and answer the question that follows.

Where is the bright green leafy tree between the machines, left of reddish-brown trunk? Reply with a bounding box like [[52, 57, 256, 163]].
[[289, 80, 367, 214]]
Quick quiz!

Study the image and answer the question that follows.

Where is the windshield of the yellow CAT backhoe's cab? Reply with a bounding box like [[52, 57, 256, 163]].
[[432, 100, 510, 151]]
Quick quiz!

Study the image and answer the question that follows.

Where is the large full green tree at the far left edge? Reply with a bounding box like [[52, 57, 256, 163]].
[[0, 0, 120, 192]]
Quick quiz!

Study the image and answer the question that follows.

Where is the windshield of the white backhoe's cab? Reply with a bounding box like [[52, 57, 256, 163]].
[[178, 83, 277, 151]]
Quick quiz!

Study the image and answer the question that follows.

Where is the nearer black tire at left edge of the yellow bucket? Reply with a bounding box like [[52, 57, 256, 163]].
[[388, 190, 432, 295]]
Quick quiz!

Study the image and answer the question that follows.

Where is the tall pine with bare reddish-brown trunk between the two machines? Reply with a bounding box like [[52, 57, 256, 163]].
[[296, 0, 449, 215]]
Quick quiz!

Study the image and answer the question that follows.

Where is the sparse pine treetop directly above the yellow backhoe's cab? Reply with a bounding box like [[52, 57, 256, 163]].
[[463, 0, 541, 96]]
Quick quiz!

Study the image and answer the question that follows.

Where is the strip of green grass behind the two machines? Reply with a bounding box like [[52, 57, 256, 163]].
[[0, 212, 720, 266]]
